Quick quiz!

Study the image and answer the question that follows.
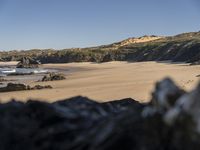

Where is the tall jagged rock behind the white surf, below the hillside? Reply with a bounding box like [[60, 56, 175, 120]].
[[17, 57, 40, 68]]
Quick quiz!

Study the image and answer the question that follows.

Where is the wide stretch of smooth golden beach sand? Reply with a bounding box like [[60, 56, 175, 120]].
[[0, 62, 200, 102]]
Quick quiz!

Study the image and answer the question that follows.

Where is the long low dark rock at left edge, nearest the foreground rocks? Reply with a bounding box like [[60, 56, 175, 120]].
[[0, 83, 52, 92]]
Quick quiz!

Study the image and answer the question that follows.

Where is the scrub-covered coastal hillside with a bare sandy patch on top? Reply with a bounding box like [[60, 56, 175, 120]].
[[0, 32, 200, 63]]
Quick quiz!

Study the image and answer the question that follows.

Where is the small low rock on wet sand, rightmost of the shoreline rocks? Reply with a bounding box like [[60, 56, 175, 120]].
[[42, 73, 66, 81]]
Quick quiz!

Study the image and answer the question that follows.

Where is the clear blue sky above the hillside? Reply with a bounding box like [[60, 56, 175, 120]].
[[0, 0, 200, 50]]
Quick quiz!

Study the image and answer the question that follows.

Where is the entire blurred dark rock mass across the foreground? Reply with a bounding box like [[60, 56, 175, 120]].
[[0, 79, 200, 150]]
